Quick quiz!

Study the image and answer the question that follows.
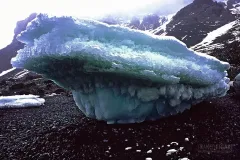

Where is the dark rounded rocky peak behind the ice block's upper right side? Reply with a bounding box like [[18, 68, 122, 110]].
[[162, 0, 236, 46]]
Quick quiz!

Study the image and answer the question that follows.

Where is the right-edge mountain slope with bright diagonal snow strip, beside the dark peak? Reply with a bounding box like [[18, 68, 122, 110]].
[[187, 0, 240, 79]]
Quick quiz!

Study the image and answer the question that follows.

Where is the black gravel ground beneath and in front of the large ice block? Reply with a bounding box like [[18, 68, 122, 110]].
[[0, 74, 240, 160]]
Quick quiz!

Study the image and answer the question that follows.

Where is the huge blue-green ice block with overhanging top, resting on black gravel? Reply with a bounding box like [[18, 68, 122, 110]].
[[12, 14, 229, 123]]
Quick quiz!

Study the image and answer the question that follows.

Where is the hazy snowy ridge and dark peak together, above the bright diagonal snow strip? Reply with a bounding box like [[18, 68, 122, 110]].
[[102, 0, 240, 47]]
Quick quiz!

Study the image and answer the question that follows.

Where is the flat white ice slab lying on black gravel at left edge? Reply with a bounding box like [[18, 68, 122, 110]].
[[0, 95, 45, 109]]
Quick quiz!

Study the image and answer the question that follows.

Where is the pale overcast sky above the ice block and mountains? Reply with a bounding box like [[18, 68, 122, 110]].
[[0, 0, 189, 49]]
